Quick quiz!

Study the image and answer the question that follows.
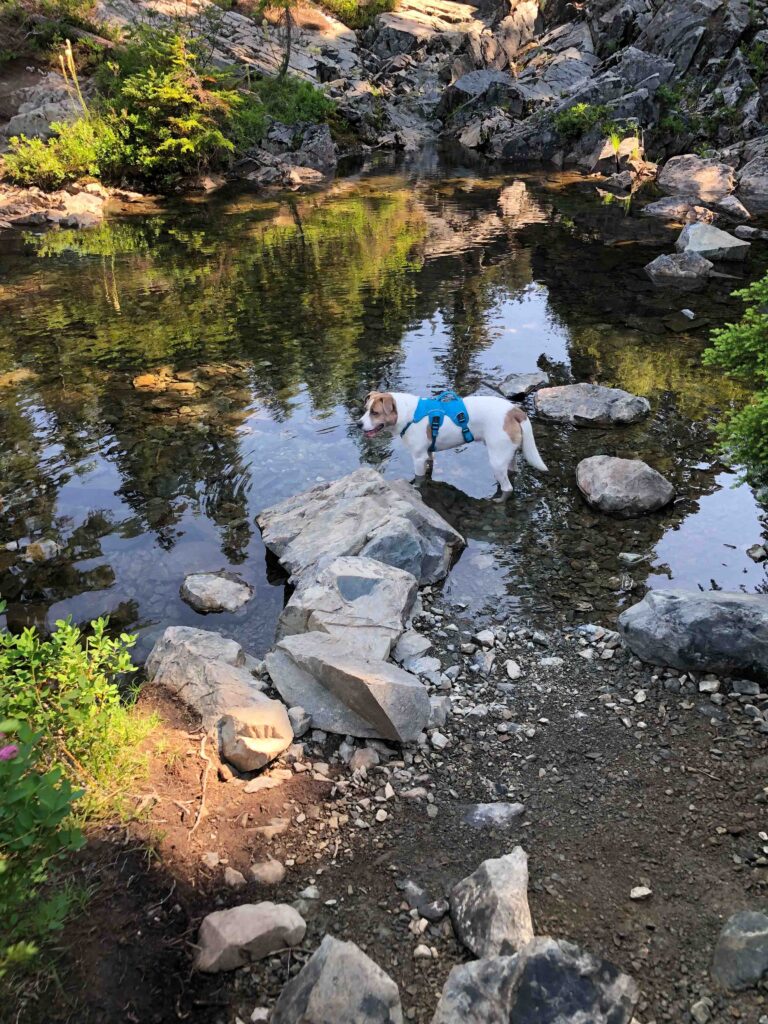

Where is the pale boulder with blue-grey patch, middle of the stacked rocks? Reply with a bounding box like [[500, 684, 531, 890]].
[[278, 556, 419, 658]]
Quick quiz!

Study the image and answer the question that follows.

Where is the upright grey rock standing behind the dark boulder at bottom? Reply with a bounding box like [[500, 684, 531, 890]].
[[451, 846, 534, 956]]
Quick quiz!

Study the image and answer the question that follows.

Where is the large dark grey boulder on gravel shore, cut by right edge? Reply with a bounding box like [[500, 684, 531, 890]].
[[618, 590, 768, 680]]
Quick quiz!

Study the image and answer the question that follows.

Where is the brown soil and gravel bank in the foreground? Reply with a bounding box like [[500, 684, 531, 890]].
[[7, 596, 768, 1024]]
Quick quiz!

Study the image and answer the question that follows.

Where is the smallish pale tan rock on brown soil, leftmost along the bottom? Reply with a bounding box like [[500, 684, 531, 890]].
[[195, 902, 306, 974]]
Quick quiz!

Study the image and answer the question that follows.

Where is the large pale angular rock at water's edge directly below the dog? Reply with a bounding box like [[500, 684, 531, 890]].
[[257, 468, 465, 584]]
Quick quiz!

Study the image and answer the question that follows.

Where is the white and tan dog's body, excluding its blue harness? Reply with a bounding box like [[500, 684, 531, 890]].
[[357, 391, 548, 499]]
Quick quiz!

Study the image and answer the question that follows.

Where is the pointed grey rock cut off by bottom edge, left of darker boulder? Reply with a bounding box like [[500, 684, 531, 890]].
[[271, 935, 402, 1024]]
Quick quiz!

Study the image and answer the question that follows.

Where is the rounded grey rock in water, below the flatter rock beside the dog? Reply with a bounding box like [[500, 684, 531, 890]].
[[577, 455, 675, 519]]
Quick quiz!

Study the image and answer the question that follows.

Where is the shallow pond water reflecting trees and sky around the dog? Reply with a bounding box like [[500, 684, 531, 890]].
[[0, 159, 768, 653]]
